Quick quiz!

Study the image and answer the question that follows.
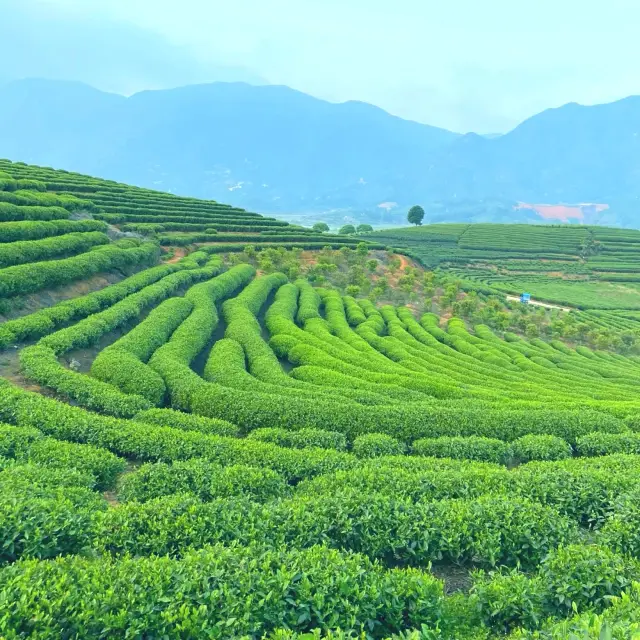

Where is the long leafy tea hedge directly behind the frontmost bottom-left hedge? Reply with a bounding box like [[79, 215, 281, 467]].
[[94, 491, 578, 569]]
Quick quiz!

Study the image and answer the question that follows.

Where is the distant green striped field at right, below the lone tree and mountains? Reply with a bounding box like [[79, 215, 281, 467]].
[[368, 224, 640, 309]]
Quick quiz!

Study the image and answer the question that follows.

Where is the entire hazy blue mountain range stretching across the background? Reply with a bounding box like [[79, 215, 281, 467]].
[[0, 80, 640, 226]]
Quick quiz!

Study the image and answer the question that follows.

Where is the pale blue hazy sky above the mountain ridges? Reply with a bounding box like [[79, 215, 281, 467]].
[[5, 0, 640, 133]]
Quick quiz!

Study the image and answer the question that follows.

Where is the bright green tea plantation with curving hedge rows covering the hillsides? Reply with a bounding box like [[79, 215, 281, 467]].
[[0, 161, 640, 640]]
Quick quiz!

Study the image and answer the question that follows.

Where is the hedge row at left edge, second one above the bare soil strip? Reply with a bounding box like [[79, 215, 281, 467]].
[[0, 228, 109, 274]]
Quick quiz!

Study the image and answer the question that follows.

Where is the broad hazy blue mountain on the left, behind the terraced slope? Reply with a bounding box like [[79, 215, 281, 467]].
[[0, 80, 458, 210]]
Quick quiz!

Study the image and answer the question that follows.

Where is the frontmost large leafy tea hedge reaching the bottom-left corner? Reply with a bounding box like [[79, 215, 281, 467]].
[[0, 545, 443, 640]]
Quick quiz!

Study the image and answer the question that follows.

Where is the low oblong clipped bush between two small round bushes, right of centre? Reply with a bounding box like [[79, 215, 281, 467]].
[[411, 436, 512, 464]]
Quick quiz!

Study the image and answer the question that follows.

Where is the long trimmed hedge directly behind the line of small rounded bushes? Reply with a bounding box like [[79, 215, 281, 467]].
[[187, 372, 627, 443]]
